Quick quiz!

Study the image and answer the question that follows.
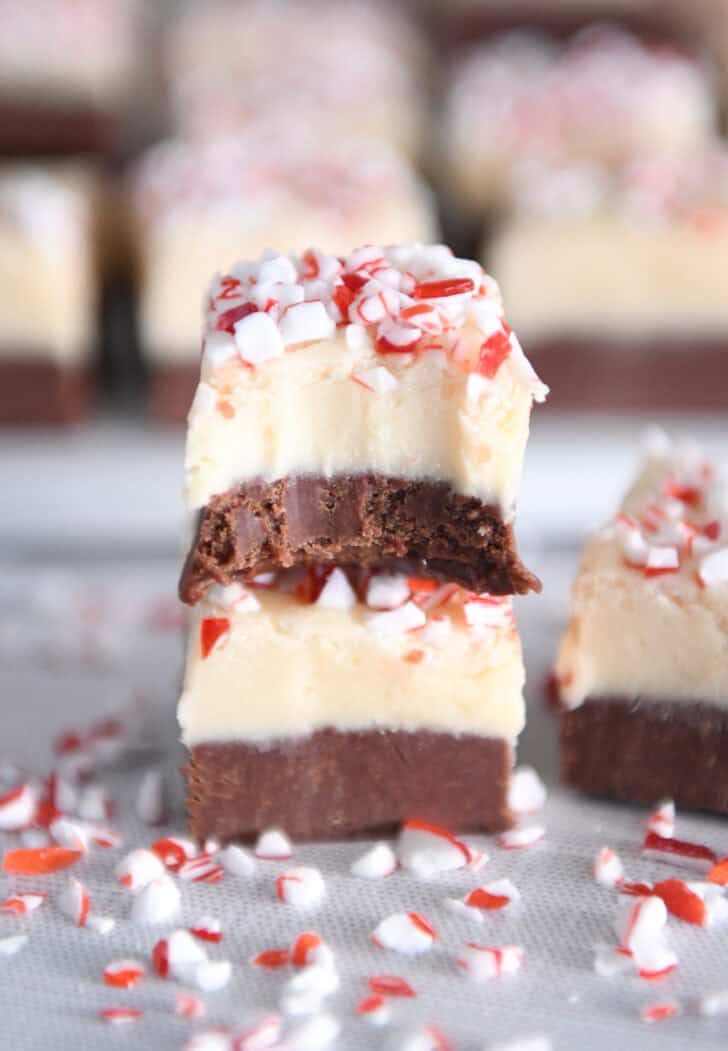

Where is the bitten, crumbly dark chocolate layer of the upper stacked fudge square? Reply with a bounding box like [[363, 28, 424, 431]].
[[180, 475, 540, 603]]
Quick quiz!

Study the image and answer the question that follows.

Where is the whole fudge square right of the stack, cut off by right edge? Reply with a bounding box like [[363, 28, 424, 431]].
[[556, 439, 728, 813]]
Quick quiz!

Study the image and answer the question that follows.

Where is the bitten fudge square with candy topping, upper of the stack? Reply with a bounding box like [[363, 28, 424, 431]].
[[181, 245, 546, 603]]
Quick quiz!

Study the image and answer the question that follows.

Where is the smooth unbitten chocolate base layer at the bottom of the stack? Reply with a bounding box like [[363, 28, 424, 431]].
[[187, 729, 513, 841]]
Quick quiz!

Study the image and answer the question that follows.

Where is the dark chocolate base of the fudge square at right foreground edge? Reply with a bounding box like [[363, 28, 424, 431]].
[[561, 698, 728, 813]]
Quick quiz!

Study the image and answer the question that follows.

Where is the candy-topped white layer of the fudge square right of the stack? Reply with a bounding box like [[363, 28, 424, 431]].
[[557, 435, 728, 707]]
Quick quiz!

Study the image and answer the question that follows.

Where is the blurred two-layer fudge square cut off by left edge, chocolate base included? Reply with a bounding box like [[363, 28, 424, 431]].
[[0, 165, 97, 425]]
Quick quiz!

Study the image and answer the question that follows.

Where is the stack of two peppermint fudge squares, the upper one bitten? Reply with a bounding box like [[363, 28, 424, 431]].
[[179, 244, 546, 840]]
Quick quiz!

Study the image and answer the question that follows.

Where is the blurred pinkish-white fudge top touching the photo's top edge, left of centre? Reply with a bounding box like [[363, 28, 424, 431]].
[[165, 0, 427, 154]]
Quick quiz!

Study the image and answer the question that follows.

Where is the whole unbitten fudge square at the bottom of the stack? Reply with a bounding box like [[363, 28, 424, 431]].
[[179, 566, 524, 841]]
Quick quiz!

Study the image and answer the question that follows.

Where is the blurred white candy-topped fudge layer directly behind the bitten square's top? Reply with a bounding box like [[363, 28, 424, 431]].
[[132, 139, 437, 365]]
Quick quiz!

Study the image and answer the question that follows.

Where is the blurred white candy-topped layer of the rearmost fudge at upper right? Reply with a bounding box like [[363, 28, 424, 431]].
[[443, 27, 716, 214]]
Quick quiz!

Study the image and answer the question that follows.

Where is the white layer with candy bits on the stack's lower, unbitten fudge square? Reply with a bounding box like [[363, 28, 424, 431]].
[[179, 569, 524, 748]]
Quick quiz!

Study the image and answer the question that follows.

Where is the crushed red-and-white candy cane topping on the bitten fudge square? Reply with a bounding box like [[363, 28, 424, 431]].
[[202, 244, 547, 400]]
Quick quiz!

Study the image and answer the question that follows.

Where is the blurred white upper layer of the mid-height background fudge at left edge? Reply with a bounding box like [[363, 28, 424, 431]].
[[0, 165, 97, 366]]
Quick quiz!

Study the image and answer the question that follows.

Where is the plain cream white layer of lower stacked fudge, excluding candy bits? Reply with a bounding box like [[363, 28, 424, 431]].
[[179, 589, 524, 747]]
